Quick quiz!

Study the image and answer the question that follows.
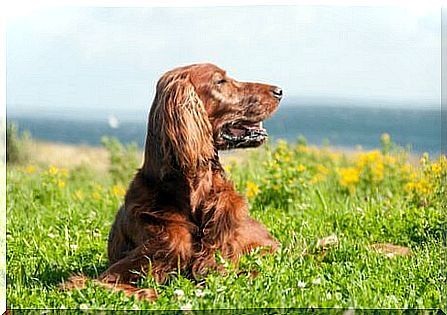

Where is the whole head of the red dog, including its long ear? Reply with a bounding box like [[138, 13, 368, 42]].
[[146, 64, 282, 177]]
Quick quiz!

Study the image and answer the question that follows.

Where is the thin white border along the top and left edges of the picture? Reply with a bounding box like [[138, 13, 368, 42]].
[[0, 0, 447, 314]]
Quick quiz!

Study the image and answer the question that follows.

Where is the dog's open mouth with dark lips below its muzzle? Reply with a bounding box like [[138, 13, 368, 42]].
[[221, 121, 268, 149]]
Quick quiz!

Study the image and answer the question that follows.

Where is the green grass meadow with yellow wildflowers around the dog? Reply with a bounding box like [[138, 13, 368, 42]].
[[7, 137, 447, 309]]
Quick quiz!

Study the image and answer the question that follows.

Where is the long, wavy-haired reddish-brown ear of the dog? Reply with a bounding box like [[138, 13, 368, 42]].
[[144, 71, 214, 178]]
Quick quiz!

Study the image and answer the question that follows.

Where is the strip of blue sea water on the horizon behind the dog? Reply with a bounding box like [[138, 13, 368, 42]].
[[8, 106, 441, 155]]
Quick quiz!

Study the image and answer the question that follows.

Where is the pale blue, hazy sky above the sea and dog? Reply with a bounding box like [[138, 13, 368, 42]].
[[6, 5, 441, 115]]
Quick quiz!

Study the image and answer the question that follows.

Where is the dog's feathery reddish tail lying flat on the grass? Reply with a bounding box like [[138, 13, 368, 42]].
[[59, 274, 158, 302]]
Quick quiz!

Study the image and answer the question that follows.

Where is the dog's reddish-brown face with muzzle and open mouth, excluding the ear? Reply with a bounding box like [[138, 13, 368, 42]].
[[189, 64, 282, 149]]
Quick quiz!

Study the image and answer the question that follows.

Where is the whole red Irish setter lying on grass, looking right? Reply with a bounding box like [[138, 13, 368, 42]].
[[65, 64, 282, 300]]
